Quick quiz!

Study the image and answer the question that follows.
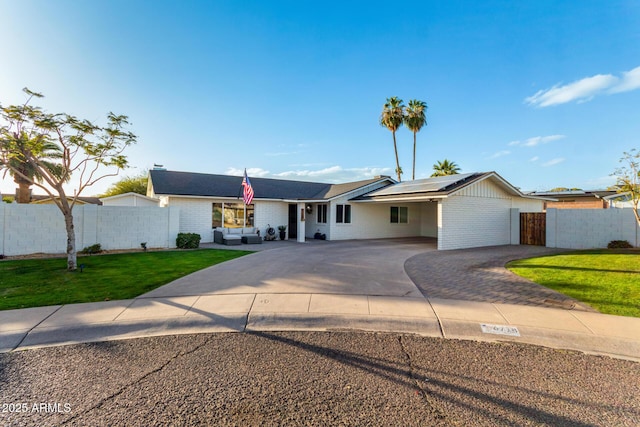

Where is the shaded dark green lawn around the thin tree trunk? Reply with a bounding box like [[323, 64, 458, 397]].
[[0, 249, 251, 310]]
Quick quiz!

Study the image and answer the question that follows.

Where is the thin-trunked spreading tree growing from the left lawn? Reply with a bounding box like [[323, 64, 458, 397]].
[[0, 88, 136, 271]]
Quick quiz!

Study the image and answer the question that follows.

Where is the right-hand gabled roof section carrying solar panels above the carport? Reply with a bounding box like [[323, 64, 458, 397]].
[[352, 172, 540, 202]]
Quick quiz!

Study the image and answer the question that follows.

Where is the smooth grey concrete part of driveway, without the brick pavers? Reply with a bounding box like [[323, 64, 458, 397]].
[[142, 238, 436, 298]]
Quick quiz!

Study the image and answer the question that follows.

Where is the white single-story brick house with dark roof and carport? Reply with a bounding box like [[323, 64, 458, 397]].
[[147, 170, 544, 249]]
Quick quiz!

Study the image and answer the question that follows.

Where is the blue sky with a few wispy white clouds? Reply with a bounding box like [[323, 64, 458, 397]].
[[0, 0, 640, 195]]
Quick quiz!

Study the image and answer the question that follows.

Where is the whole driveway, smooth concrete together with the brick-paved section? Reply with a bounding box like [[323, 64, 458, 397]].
[[142, 238, 591, 311]]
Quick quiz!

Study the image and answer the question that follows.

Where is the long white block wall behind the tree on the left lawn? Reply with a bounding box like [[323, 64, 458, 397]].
[[0, 203, 180, 256]]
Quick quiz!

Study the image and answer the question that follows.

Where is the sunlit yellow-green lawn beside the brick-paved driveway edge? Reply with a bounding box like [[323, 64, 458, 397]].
[[507, 249, 640, 317]]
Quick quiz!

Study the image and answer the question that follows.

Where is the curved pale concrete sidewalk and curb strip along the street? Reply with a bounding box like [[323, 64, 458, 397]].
[[0, 294, 640, 361]]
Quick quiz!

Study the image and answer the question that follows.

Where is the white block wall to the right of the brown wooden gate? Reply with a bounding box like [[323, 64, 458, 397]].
[[547, 209, 640, 249]]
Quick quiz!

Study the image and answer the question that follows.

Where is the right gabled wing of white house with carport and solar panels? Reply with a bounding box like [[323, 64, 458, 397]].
[[350, 172, 544, 250]]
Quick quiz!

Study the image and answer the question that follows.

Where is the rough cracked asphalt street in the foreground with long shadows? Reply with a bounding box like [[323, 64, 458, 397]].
[[0, 332, 640, 426]]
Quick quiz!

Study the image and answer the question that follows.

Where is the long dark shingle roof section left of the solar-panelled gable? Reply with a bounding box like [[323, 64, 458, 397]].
[[149, 170, 395, 201]]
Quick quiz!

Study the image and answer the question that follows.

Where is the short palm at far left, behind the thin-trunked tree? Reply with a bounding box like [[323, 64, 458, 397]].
[[0, 132, 62, 203]]
